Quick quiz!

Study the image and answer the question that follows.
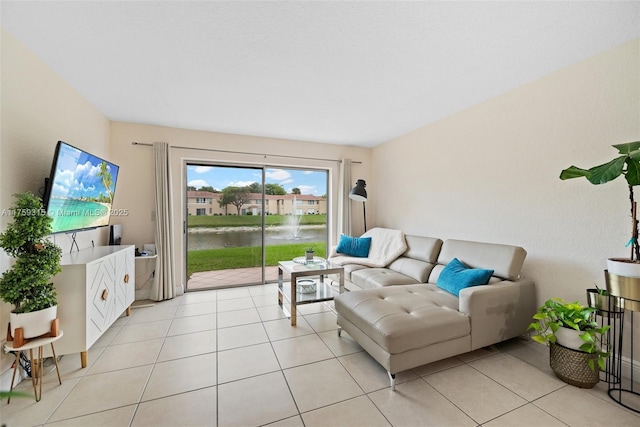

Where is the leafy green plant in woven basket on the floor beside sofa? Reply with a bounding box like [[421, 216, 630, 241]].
[[529, 298, 609, 388]]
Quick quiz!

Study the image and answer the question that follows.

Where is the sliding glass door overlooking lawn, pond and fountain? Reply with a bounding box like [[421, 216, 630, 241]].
[[185, 163, 328, 290]]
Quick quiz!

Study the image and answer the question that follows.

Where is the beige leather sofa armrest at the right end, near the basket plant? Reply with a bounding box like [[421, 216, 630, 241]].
[[459, 279, 537, 350]]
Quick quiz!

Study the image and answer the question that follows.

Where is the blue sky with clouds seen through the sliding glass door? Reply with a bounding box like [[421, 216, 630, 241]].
[[187, 165, 327, 196]]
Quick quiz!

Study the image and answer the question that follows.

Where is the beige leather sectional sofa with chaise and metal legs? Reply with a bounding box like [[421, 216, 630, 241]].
[[330, 231, 536, 388]]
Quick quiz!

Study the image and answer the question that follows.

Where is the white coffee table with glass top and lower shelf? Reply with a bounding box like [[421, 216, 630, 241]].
[[278, 258, 344, 326]]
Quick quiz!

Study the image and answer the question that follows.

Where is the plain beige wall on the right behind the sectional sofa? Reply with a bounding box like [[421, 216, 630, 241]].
[[367, 39, 640, 354]]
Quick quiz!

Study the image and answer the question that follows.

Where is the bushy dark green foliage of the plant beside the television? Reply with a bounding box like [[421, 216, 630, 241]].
[[0, 192, 62, 313]]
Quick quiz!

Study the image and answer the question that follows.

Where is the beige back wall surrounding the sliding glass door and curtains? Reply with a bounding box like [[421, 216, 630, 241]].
[[110, 122, 373, 294]]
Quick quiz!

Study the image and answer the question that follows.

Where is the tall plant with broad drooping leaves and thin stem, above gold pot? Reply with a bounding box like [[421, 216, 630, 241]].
[[560, 141, 640, 262]]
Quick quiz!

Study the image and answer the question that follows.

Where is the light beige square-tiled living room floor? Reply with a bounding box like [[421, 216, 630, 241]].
[[0, 285, 640, 427]]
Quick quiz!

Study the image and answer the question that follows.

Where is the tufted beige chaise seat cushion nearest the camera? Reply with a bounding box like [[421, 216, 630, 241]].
[[335, 284, 471, 354]]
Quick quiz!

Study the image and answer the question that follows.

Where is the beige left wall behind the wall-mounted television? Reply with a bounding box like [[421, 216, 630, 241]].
[[0, 29, 109, 338]]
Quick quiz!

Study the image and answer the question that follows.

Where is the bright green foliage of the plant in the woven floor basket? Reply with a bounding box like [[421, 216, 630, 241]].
[[529, 298, 609, 370]]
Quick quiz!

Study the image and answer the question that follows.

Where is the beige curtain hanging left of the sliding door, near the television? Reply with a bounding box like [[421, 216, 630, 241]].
[[150, 142, 175, 301]]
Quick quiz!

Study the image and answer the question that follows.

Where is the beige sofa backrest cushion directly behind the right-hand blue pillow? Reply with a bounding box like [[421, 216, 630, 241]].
[[438, 239, 527, 283]]
